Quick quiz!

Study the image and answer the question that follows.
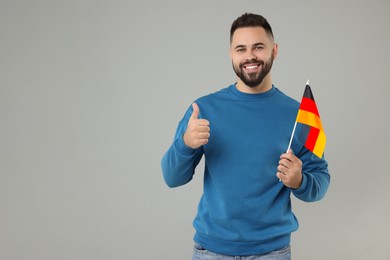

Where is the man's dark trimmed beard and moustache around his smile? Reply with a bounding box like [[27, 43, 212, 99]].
[[232, 55, 274, 88]]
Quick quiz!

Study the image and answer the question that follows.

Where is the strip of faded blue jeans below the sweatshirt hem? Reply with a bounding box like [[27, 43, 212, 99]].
[[192, 243, 291, 260]]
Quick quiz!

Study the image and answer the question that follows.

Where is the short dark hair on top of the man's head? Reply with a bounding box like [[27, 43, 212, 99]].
[[230, 13, 274, 42]]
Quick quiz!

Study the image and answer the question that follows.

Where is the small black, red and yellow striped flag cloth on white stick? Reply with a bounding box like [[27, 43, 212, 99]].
[[296, 83, 326, 158]]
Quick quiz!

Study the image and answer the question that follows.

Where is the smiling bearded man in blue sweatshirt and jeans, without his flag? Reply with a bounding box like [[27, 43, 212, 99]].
[[161, 13, 330, 259]]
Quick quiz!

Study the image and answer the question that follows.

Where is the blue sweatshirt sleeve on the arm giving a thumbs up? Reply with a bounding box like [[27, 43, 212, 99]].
[[161, 108, 203, 188]]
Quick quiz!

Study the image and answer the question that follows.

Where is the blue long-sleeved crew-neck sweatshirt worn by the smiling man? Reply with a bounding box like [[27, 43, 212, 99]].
[[161, 85, 330, 255]]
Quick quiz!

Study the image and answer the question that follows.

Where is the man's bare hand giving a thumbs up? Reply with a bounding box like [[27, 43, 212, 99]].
[[183, 103, 210, 149]]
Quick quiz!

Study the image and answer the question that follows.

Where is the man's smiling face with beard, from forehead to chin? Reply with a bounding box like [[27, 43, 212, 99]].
[[230, 27, 277, 88]]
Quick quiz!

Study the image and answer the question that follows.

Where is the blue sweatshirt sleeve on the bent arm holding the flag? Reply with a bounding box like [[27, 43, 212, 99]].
[[292, 149, 330, 202]]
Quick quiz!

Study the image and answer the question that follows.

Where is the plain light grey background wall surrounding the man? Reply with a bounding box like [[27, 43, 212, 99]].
[[0, 0, 390, 260]]
